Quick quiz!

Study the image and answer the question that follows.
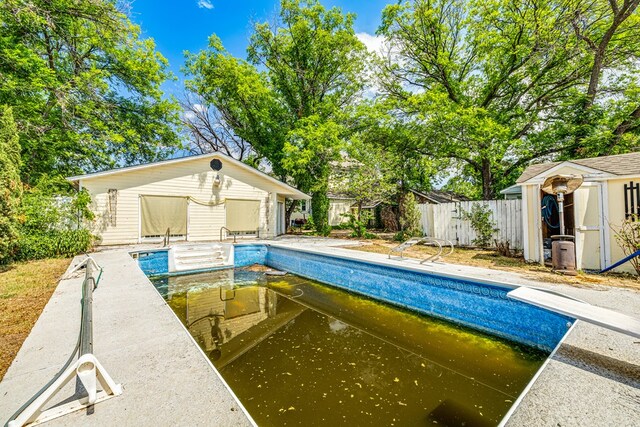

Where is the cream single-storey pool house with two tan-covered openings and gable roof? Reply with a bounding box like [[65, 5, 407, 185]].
[[67, 153, 309, 245]]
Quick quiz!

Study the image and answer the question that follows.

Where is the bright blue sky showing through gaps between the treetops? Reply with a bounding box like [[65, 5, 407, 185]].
[[131, 0, 394, 96]]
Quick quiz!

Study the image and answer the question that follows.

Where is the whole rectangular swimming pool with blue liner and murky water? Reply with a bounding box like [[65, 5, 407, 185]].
[[140, 245, 573, 425]]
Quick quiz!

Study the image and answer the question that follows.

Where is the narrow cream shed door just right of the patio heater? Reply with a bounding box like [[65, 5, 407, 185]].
[[573, 184, 603, 270]]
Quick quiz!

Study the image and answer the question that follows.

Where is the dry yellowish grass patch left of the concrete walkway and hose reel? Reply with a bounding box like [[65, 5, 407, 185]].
[[0, 259, 70, 380]]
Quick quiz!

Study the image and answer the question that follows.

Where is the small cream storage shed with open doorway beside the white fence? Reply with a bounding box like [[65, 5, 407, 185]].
[[517, 152, 640, 272]]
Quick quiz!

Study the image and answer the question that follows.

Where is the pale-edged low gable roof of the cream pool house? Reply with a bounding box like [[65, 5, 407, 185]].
[[67, 152, 311, 199]]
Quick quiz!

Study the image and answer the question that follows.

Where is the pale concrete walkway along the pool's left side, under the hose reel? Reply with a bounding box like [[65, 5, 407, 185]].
[[0, 250, 251, 426]]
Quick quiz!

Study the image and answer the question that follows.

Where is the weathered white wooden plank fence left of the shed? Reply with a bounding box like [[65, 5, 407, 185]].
[[418, 200, 523, 249]]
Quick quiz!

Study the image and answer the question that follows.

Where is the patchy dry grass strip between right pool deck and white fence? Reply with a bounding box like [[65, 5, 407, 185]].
[[345, 240, 640, 291]]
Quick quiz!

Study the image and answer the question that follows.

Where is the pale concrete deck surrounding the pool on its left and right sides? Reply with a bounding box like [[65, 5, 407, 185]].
[[0, 239, 640, 426]]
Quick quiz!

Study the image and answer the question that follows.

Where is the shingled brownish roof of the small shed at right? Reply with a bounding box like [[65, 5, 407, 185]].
[[516, 152, 640, 184]]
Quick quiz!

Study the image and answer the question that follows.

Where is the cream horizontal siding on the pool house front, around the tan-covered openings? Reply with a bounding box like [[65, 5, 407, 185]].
[[81, 158, 275, 245]]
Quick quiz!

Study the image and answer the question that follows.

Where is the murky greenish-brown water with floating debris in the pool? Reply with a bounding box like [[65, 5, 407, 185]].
[[152, 270, 547, 426]]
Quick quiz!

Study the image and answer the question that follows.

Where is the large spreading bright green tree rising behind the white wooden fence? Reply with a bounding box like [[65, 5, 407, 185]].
[[379, 0, 640, 199]]
